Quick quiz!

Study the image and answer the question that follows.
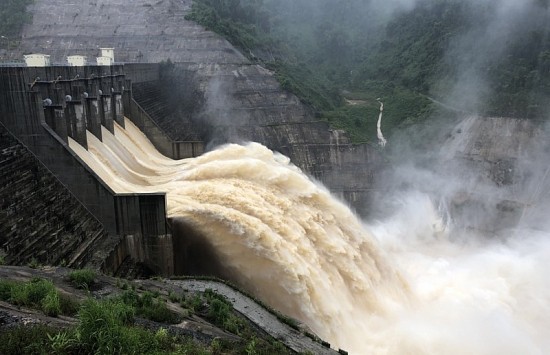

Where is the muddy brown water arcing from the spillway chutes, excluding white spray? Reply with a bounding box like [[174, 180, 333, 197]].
[[70, 121, 407, 350]]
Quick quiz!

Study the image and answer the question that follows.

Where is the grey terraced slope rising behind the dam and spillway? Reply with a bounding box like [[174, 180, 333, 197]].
[[9, 0, 385, 214]]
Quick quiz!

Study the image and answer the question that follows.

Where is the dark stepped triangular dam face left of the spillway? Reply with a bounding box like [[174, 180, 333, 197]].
[[0, 125, 111, 267]]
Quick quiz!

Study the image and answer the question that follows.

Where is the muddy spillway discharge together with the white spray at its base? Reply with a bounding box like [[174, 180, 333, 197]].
[[70, 120, 550, 354]]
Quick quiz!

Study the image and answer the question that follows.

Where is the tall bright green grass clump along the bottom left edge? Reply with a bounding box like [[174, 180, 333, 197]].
[[0, 299, 212, 355]]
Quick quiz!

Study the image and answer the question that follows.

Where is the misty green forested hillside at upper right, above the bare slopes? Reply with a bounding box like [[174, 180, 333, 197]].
[[189, 0, 550, 141]]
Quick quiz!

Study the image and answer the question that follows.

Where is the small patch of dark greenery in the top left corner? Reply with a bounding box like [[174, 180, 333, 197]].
[[0, 0, 33, 49]]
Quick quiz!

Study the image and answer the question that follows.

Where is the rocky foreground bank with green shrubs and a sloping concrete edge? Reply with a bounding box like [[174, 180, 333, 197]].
[[0, 266, 337, 355]]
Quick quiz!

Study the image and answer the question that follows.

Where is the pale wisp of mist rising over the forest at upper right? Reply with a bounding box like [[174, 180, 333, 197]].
[[442, 0, 548, 112]]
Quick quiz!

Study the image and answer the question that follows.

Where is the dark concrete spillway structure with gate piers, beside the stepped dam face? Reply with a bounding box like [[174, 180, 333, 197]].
[[0, 66, 173, 274]]
